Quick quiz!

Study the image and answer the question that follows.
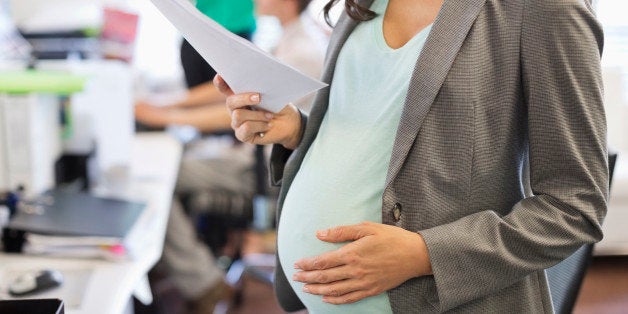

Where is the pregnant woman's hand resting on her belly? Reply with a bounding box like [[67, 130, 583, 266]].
[[292, 222, 432, 304]]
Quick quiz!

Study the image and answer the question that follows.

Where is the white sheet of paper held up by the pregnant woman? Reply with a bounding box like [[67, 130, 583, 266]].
[[151, 0, 326, 112]]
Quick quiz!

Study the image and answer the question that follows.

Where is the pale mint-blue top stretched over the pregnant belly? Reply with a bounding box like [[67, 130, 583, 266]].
[[278, 0, 431, 314]]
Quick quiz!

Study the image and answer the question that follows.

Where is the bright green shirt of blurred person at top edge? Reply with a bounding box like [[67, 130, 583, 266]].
[[196, 0, 255, 34]]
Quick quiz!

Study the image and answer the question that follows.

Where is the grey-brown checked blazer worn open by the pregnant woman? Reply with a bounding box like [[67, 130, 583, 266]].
[[271, 0, 608, 313]]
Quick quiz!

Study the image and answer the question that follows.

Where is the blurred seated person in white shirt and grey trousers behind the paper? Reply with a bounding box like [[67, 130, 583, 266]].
[[135, 0, 327, 313]]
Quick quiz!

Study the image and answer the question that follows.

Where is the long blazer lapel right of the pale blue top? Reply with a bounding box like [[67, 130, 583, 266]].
[[386, 0, 486, 186]]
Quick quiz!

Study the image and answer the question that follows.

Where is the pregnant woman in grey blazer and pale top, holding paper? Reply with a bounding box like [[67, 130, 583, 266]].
[[214, 0, 609, 314]]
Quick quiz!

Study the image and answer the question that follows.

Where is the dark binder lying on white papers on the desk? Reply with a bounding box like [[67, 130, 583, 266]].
[[8, 191, 145, 259]]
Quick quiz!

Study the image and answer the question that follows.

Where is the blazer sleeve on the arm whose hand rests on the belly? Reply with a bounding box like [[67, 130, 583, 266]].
[[419, 0, 609, 311]]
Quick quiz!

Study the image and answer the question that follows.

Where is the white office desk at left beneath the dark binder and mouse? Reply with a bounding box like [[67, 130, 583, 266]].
[[0, 133, 182, 314]]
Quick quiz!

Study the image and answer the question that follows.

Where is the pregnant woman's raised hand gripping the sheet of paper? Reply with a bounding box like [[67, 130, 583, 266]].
[[214, 75, 301, 149]]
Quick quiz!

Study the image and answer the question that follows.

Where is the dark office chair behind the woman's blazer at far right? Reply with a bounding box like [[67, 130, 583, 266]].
[[545, 153, 617, 314]]
